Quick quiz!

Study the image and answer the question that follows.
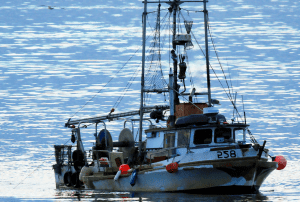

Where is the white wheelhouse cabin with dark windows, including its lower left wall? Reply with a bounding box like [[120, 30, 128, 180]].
[[145, 123, 248, 163]]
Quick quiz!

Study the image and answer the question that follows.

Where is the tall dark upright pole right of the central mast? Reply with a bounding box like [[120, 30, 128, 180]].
[[203, 0, 211, 107]]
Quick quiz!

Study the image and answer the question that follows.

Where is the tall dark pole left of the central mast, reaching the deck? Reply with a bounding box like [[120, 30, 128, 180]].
[[139, 0, 147, 158]]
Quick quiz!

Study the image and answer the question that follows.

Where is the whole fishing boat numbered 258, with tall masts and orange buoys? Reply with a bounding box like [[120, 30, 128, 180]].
[[53, 0, 286, 193]]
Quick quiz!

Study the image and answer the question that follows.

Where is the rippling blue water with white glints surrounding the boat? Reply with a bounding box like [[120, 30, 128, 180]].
[[0, 0, 300, 201]]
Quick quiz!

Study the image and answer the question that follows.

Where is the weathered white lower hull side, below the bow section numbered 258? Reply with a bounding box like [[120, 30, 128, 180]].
[[84, 162, 276, 192]]
